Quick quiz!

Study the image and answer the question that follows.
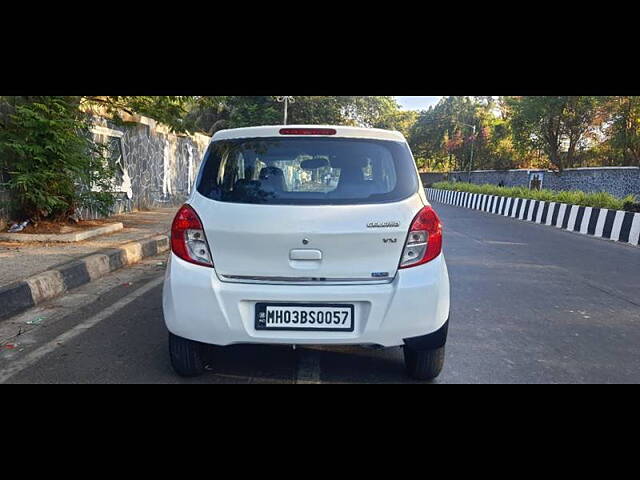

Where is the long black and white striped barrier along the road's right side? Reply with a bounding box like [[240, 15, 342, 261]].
[[426, 188, 640, 245]]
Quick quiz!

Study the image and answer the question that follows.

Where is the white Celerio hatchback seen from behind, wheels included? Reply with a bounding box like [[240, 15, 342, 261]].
[[163, 126, 449, 379]]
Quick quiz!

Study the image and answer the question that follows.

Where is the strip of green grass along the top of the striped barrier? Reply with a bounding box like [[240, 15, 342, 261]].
[[432, 182, 635, 210]]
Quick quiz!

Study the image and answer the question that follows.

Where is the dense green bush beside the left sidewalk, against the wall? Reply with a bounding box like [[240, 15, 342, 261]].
[[0, 96, 114, 220]]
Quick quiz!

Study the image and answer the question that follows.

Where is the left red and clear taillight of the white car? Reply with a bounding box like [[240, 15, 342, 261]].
[[171, 205, 213, 267]]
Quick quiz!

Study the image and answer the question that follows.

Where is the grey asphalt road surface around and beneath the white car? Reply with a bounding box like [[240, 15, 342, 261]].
[[0, 205, 640, 383]]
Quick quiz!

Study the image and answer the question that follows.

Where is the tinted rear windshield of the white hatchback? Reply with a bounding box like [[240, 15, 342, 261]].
[[197, 137, 418, 205]]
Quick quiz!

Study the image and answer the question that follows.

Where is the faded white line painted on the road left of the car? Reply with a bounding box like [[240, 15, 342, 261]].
[[0, 276, 164, 383]]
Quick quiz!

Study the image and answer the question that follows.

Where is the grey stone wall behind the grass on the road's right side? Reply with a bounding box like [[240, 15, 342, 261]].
[[448, 167, 640, 198]]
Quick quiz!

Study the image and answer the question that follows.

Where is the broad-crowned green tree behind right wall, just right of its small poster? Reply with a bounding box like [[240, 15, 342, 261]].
[[506, 96, 605, 171]]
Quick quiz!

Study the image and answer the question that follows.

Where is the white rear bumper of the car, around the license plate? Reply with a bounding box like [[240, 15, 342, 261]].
[[163, 254, 449, 347]]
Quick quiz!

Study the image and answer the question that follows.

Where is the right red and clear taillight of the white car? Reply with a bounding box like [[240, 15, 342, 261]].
[[400, 207, 442, 268]]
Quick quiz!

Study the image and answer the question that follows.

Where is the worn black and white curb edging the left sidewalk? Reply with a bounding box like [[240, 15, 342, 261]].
[[0, 235, 169, 320]]
